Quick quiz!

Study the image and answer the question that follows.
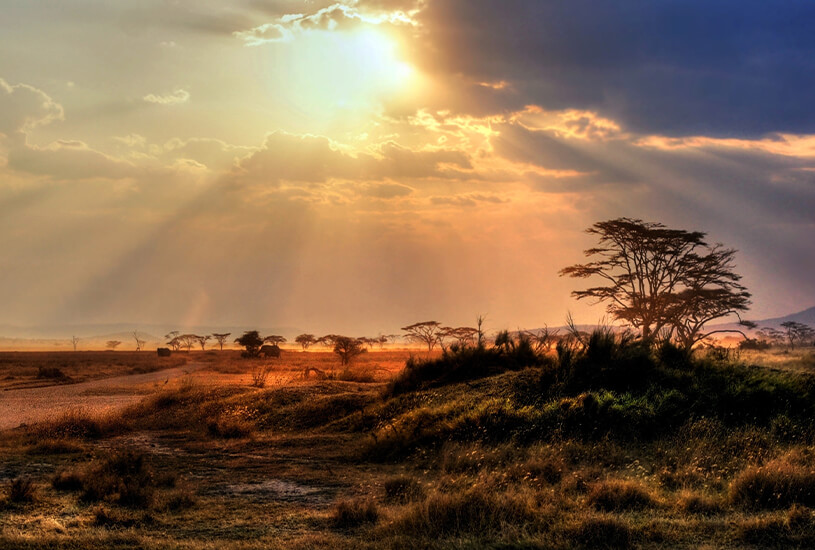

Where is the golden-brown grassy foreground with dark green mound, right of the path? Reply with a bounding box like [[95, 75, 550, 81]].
[[0, 344, 815, 549]]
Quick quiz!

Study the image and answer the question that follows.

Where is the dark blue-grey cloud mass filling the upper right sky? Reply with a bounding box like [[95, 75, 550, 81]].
[[417, 0, 815, 135]]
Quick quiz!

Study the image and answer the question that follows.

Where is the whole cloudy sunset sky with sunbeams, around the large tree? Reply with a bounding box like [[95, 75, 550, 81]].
[[0, 0, 815, 335]]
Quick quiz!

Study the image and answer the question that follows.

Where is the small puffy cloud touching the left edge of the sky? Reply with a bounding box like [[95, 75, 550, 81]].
[[0, 78, 64, 137]]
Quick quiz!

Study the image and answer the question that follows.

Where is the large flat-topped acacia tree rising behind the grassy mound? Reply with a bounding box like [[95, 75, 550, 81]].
[[560, 218, 750, 349]]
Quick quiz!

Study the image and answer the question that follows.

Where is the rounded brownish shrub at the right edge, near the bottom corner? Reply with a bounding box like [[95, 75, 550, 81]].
[[730, 459, 815, 509]]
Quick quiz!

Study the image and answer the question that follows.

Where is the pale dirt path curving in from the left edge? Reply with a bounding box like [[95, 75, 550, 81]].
[[0, 363, 204, 430]]
